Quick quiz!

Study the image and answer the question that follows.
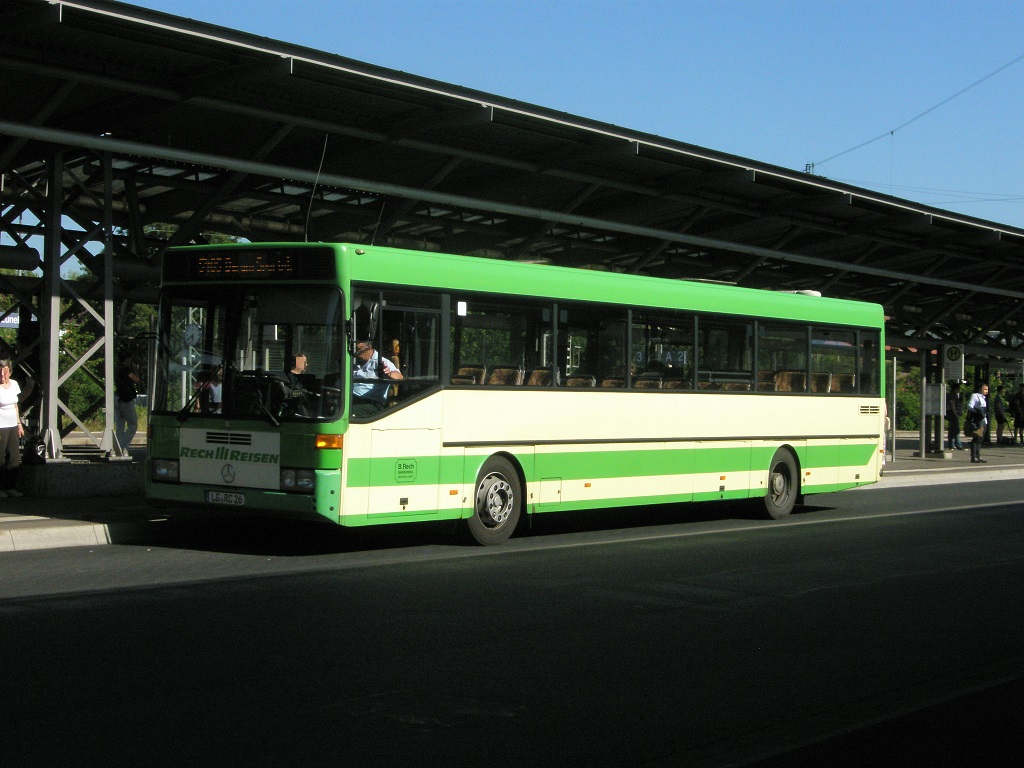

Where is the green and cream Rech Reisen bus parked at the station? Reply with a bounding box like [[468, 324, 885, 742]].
[[146, 244, 885, 544]]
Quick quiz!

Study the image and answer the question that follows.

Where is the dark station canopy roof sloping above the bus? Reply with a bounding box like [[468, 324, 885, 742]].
[[6, 0, 1024, 357]]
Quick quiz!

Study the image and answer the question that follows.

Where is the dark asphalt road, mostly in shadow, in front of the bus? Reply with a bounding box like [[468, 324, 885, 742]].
[[0, 481, 1024, 768]]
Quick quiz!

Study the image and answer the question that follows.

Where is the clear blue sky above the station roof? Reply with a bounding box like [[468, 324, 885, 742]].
[[121, 0, 1024, 227]]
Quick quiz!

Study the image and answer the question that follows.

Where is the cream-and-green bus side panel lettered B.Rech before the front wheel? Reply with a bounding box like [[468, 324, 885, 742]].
[[367, 428, 441, 522]]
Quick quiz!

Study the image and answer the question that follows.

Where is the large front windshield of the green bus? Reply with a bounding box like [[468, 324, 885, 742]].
[[154, 285, 347, 424]]
